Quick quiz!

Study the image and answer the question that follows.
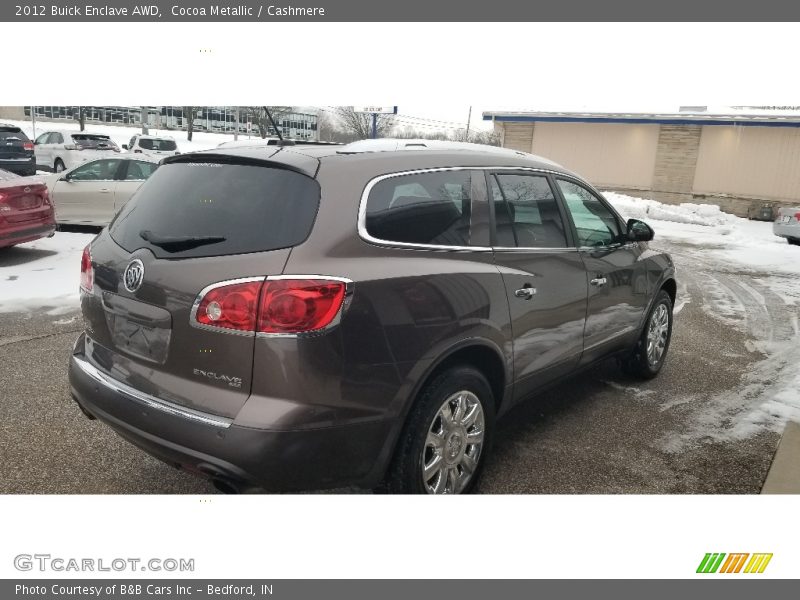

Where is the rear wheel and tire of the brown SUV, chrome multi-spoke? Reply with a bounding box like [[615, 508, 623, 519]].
[[382, 366, 495, 494]]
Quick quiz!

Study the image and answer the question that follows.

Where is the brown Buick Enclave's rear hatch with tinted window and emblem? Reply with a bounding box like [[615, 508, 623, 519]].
[[82, 154, 320, 418]]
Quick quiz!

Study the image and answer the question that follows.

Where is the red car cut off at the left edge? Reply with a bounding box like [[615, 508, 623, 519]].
[[0, 169, 56, 248]]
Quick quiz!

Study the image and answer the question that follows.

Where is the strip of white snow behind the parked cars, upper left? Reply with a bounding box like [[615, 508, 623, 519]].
[[3, 119, 247, 152]]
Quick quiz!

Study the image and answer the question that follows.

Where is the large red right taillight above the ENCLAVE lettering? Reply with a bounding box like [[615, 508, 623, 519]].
[[193, 278, 347, 335]]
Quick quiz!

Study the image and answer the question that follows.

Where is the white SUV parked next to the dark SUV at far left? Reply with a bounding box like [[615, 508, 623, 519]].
[[34, 131, 120, 173]]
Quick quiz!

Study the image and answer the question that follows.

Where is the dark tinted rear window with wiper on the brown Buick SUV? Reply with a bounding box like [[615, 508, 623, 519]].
[[109, 163, 320, 258]]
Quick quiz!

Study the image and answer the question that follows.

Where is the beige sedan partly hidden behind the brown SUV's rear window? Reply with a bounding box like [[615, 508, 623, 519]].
[[47, 154, 158, 227]]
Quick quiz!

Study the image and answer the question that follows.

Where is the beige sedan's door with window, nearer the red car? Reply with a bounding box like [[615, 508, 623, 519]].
[[53, 158, 121, 226]]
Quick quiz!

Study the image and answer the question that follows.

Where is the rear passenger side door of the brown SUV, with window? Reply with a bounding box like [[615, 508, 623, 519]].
[[487, 171, 588, 400]]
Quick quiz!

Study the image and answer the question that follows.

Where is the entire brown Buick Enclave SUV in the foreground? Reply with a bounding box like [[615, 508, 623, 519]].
[[69, 140, 676, 493]]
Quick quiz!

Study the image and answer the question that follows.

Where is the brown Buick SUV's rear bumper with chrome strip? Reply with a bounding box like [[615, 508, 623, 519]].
[[69, 335, 389, 491]]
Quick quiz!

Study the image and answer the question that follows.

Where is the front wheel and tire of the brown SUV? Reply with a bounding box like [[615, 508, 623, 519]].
[[622, 290, 672, 379]]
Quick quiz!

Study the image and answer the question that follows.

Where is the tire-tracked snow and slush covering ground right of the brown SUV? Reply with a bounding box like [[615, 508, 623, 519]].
[[604, 192, 800, 451]]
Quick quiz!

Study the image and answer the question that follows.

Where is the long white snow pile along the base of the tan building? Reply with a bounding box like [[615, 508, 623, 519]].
[[603, 192, 736, 227]]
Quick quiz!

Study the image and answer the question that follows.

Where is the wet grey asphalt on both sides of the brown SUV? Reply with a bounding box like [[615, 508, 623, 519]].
[[0, 237, 796, 493]]
